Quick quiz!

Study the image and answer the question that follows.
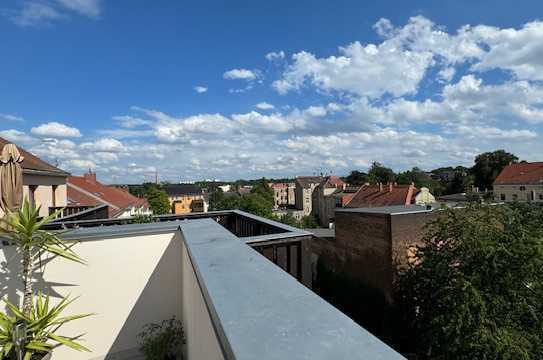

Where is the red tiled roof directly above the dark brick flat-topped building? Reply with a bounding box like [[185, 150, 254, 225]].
[[345, 184, 418, 208]]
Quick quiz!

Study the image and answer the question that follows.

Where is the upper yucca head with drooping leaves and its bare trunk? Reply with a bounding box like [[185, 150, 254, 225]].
[[0, 198, 84, 316]]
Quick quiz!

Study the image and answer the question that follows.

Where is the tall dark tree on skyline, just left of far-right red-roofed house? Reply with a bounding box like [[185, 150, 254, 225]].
[[471, 150, 518, 189]]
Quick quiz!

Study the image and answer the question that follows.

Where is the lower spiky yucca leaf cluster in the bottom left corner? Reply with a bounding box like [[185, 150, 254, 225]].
[[0, 292, 92, 360]]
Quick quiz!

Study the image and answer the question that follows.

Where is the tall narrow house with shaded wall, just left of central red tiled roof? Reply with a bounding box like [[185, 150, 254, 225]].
[[312, 176, 347, 227]]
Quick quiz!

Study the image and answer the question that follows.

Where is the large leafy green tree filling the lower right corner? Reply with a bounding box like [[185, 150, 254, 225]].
[[398, 205, 543, 360]]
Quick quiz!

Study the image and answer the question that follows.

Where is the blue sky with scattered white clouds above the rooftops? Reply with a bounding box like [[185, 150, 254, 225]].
[[0, 0, 543, 182]]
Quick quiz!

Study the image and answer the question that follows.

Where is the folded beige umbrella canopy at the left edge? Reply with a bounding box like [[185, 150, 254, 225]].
[[0, 144, 24, 214]]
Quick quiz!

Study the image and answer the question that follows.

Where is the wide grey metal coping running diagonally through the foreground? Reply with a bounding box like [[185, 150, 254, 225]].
[[180, 219, 404, 360]]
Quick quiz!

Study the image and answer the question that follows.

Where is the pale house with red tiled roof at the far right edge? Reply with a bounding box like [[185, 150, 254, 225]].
[[493, 162, 543, 202]]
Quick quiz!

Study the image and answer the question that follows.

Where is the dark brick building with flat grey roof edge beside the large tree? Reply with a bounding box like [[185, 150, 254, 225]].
[[312, 205, 439, 303]]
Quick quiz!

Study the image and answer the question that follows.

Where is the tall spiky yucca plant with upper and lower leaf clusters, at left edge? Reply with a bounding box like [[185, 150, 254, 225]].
[[0, 199, 91, 360]]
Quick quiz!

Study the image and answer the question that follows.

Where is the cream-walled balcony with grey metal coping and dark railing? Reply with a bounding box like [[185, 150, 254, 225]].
[[0, 211, 402, 360]]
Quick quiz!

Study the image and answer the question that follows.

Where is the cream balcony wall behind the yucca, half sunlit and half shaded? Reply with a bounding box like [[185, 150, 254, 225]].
[[0, 233, 183, 360]]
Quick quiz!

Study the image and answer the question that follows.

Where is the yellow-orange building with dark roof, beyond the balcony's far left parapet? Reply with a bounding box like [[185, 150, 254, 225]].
[[164, 184, 209, 215]]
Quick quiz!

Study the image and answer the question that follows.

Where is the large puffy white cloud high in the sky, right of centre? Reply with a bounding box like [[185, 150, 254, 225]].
[[273, 42, 432, 98]]
